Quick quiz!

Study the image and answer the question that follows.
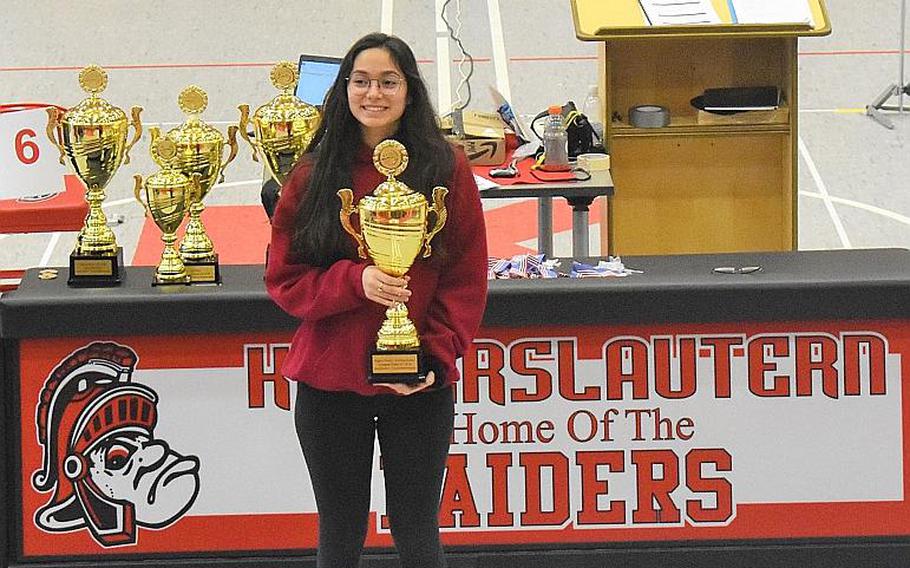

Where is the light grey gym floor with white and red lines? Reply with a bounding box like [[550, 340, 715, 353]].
[[0, 0, 910, 269]]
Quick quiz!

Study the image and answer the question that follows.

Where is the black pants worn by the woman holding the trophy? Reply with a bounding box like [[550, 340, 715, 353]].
[[295, 383, 454, 568]]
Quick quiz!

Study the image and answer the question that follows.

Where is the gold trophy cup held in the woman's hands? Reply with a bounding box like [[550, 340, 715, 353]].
[[338, 140, 449, 384]]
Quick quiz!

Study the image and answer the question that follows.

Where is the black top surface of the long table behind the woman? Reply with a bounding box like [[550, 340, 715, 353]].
[[0, 249, 910, 338]]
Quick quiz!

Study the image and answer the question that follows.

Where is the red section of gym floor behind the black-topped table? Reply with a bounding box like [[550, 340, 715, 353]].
[[132, 199, 600, 266]]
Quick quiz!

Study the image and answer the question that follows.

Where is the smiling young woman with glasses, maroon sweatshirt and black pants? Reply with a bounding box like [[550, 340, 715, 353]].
[[266, 33, 487, 568]]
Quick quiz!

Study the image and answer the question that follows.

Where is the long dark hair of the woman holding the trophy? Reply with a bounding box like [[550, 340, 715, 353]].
[[291, 33, 454, 266]]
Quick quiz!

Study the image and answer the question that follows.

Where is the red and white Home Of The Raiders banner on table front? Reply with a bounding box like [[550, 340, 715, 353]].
[[20, 322, 910, 556]]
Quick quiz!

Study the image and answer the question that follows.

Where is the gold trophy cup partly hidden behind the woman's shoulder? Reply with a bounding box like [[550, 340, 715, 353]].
[[237, 61, 322, 186]]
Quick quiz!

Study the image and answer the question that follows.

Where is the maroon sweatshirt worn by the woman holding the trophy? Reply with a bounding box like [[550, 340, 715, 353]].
[[265, 146, 487, 395]]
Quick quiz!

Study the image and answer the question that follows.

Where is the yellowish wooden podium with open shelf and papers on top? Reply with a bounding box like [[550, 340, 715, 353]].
[[572, 0, 831, 255]]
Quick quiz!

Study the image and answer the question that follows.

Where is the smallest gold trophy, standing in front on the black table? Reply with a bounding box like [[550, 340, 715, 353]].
[[133, 138, 200, 286]]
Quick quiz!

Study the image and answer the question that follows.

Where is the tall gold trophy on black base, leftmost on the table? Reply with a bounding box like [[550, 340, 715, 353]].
[[47, 65, 142, 286]]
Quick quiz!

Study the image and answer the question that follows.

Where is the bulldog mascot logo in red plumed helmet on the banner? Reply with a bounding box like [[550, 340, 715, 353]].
[[32, 342, 199, 547]]
